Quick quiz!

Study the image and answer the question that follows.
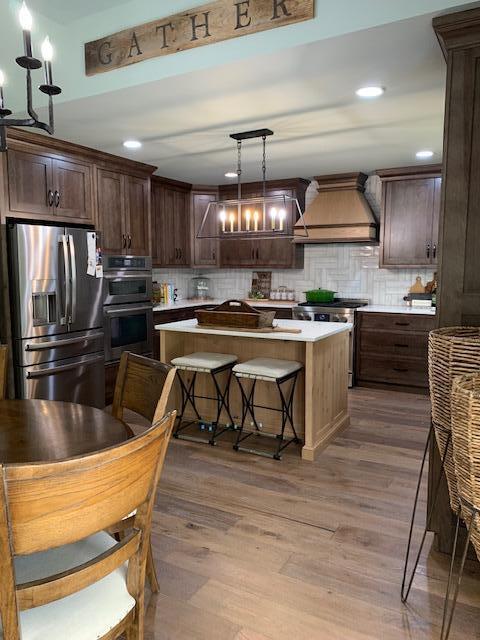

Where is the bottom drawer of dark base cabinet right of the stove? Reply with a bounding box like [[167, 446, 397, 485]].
[[359, 355, 428, 387]]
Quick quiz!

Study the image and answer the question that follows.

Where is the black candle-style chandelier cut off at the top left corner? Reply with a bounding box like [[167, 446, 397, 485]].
[[0, 2, 62, 151]]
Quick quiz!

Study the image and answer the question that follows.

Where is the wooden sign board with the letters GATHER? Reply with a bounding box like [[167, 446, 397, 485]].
[[85, 0, 315, 76]]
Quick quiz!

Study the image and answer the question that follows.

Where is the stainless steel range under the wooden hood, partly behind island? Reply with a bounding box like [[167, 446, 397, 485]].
[[293, 298, 369, 387]]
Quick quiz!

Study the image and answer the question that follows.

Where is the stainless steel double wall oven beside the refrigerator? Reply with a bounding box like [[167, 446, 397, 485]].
[[103, 256, 153, 362]]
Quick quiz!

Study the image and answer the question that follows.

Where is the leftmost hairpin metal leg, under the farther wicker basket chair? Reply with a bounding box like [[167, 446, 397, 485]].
[[401, 422, 452, 603]]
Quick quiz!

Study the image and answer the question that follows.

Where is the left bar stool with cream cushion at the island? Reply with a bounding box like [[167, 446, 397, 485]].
[[172, 352, 237, 445]]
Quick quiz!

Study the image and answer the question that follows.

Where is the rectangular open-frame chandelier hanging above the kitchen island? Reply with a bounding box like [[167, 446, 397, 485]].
[[197, 129, 308, 239]]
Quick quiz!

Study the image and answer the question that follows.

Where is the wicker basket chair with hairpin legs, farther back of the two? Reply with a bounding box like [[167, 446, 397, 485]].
[[401, 327, 480, 602]]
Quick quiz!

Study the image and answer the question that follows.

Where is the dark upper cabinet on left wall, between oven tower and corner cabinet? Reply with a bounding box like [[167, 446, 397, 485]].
[[152, 176, 191, 267]]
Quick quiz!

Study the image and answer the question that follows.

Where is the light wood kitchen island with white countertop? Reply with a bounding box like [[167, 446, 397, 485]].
[[155, 320, 351, 460]]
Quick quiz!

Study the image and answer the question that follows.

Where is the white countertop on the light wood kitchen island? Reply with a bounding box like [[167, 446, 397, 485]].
[[155, 320, 352, 342]]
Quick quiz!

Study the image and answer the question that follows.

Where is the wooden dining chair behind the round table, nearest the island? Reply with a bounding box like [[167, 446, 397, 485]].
[[112, 351, 176, 593]]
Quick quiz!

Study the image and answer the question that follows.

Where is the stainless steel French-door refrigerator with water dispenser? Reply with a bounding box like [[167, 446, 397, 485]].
[[8, 223, 105, 407]]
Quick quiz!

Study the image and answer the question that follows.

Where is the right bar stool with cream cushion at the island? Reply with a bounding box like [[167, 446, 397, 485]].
[[233, 358, 303, 460]]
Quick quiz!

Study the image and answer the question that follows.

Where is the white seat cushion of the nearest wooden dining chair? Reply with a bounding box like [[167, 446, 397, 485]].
[[6, 532, 135, 640]]
